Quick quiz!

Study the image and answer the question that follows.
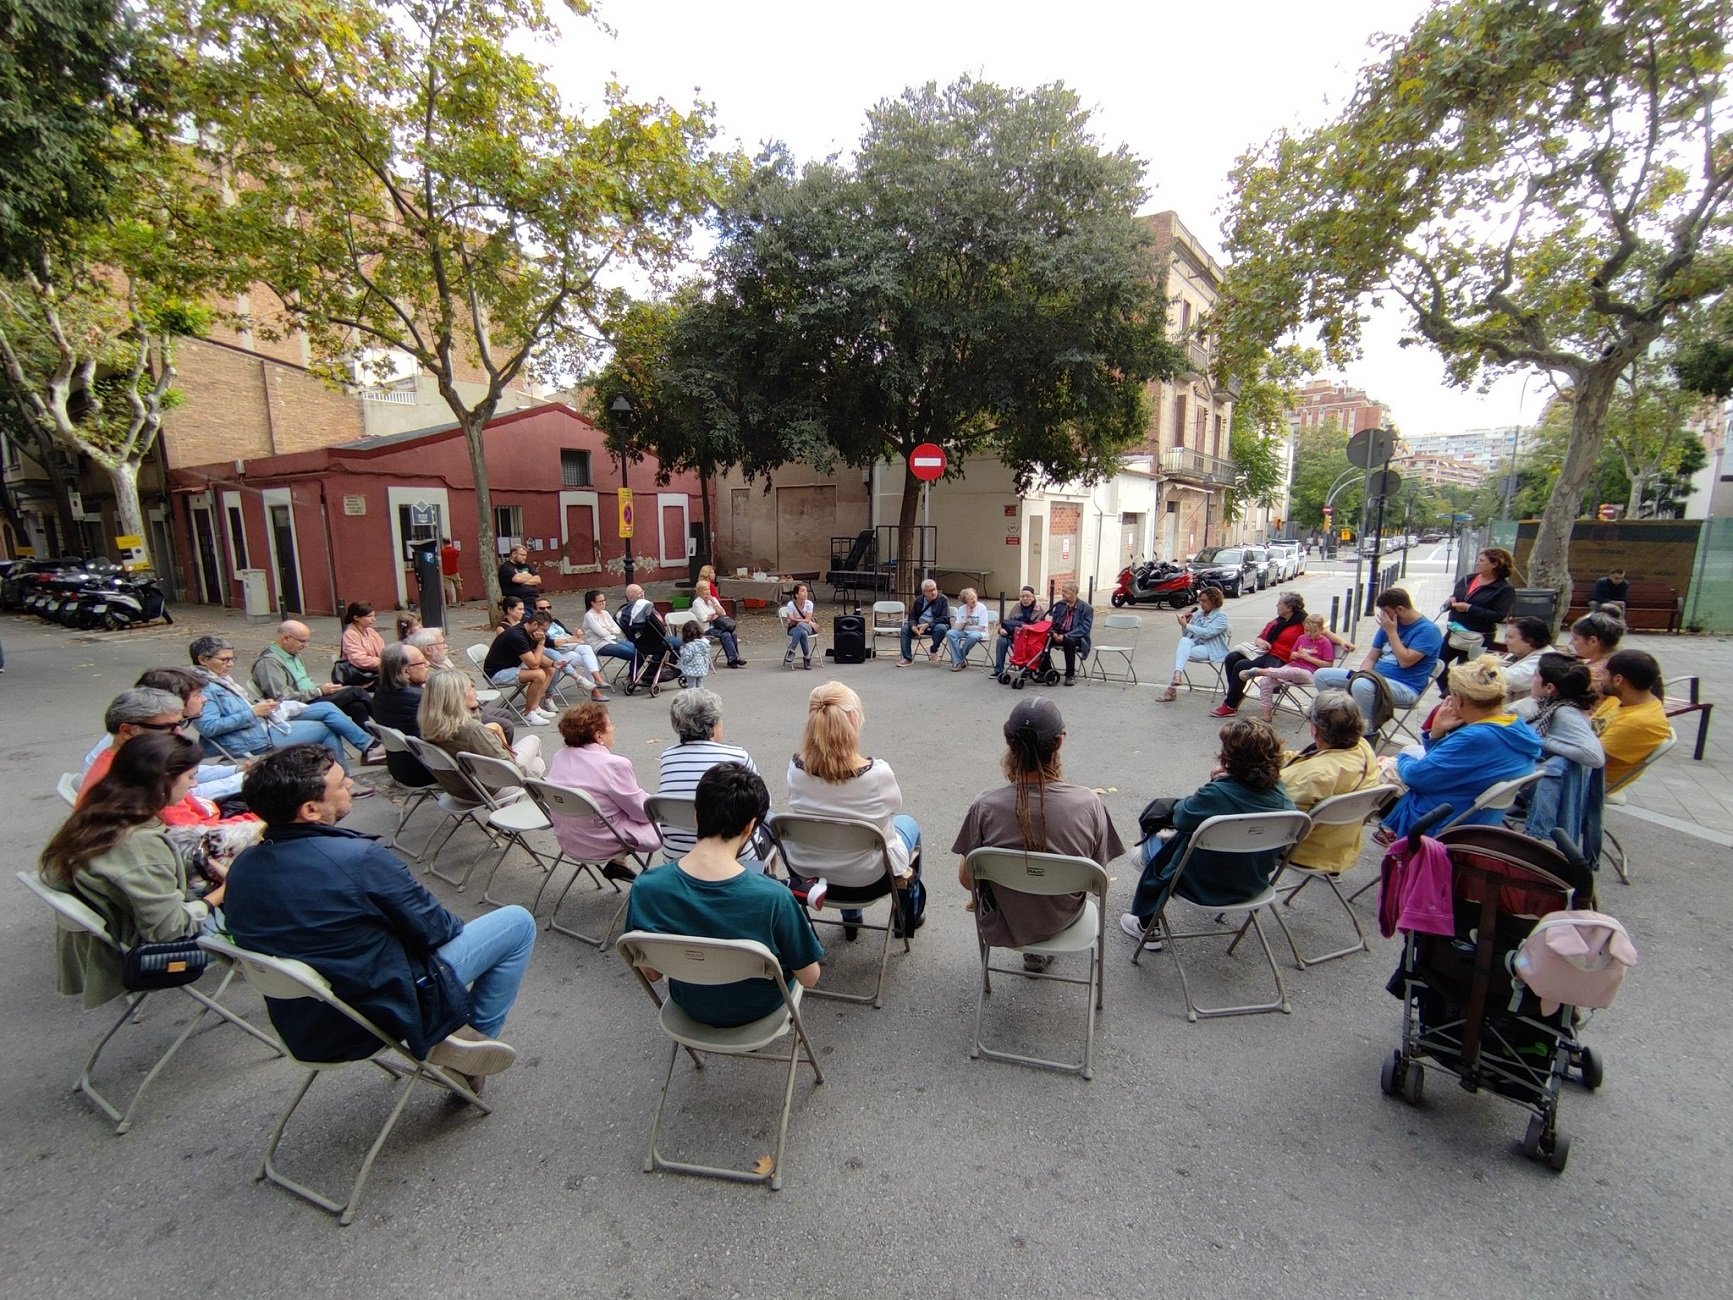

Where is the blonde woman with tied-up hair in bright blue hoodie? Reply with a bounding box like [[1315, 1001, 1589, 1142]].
[[1379, 655, 1541, 842]]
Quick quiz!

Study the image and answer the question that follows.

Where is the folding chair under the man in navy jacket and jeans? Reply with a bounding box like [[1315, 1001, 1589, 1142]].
[[199, 934, 489, 1227]]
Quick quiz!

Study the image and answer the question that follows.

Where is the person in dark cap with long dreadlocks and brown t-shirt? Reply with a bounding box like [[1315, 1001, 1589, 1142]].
[[951, 695, 1125, 971]]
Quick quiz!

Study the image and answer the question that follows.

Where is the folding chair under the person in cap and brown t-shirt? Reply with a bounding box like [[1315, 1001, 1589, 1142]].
[[969, 849, 1107, 1078]]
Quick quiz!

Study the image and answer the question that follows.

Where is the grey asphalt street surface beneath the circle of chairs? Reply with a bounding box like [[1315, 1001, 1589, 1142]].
[[0, 568, 1733, 1300]]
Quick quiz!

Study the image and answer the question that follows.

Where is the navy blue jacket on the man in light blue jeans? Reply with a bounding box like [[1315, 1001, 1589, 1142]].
[[222, 822, 466, 1061]]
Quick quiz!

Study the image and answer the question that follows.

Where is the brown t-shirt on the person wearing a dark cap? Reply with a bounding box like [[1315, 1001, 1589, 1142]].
[[951, 782, 1125, 948]]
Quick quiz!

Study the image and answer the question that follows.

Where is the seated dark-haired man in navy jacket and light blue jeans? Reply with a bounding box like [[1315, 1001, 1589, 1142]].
[[224, 745, 535, 1090]]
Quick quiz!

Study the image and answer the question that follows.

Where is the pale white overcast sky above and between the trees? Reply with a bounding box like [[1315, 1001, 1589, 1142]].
[[553, 0, 1544, 433]]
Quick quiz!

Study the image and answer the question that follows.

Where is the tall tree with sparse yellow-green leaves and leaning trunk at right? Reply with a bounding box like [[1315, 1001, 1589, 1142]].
[[1220, 0, 1733, 588]]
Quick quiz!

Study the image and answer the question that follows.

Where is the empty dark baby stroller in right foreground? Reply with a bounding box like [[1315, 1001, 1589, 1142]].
[[1379, 806, 1601, 1172]]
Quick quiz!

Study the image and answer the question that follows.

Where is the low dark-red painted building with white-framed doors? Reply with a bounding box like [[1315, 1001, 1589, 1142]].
[[172, 404, 702, 615]]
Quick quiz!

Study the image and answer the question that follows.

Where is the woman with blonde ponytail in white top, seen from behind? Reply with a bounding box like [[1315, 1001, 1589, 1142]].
[[789, 681, 927, 939]]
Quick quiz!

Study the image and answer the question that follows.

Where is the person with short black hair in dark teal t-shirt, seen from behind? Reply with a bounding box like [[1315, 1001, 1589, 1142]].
[[626, 763, 825, 1028]]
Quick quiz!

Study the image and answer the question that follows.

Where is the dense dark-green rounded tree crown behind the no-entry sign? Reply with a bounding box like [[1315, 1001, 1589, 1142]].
[[682, 78, 1182, 522]]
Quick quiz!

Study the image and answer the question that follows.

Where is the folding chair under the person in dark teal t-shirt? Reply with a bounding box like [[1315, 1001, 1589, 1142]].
[[615, 929, 825, 1191]]
